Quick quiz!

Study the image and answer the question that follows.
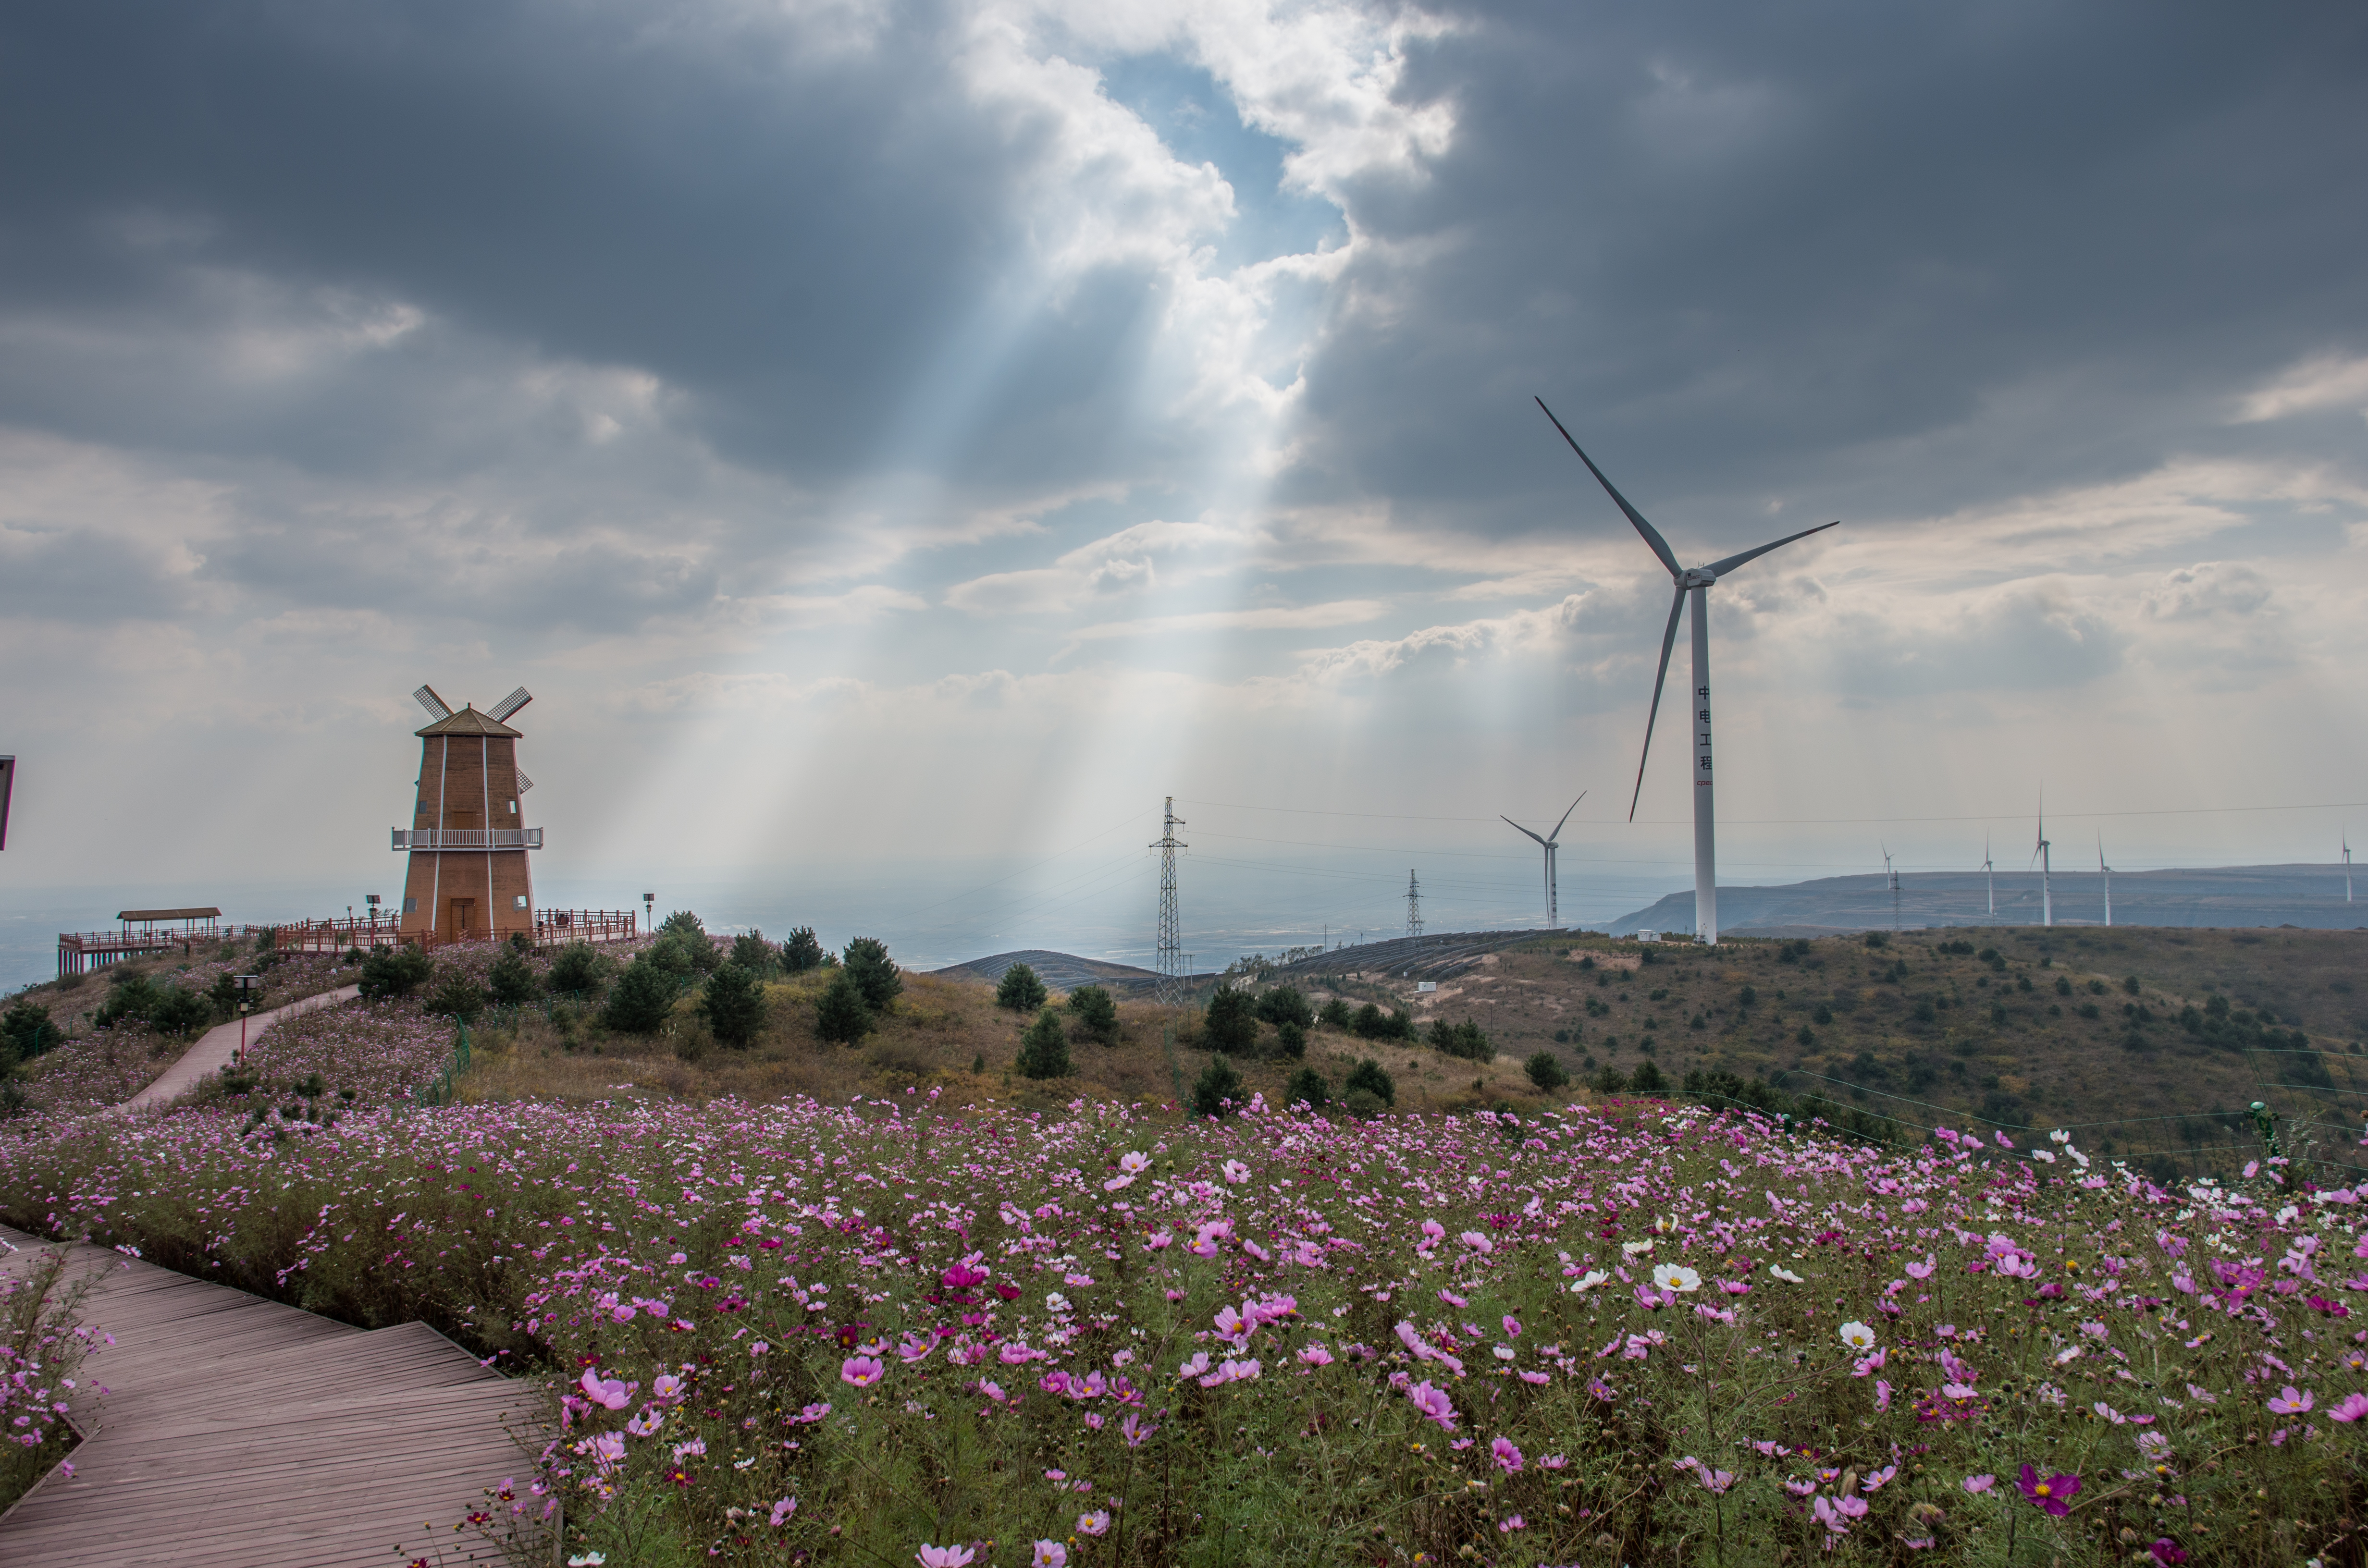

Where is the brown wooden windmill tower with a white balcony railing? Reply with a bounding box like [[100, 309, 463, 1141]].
[[393, 687, 543, 943]]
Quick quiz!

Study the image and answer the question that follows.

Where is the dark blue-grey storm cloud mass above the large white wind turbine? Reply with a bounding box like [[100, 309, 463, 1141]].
[[1293, 2, 2368, 542]]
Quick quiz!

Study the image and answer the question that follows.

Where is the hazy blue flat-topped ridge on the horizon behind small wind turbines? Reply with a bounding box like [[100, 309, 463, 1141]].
[[1610, 865, 2368, 936]]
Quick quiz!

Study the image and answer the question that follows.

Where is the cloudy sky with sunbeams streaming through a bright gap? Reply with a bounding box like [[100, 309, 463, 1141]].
[[0, 0, 2368, 980]]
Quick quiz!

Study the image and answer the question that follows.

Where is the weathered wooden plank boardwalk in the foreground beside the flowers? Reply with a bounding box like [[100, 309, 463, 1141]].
[[0, 1227, 556, 1568]]
